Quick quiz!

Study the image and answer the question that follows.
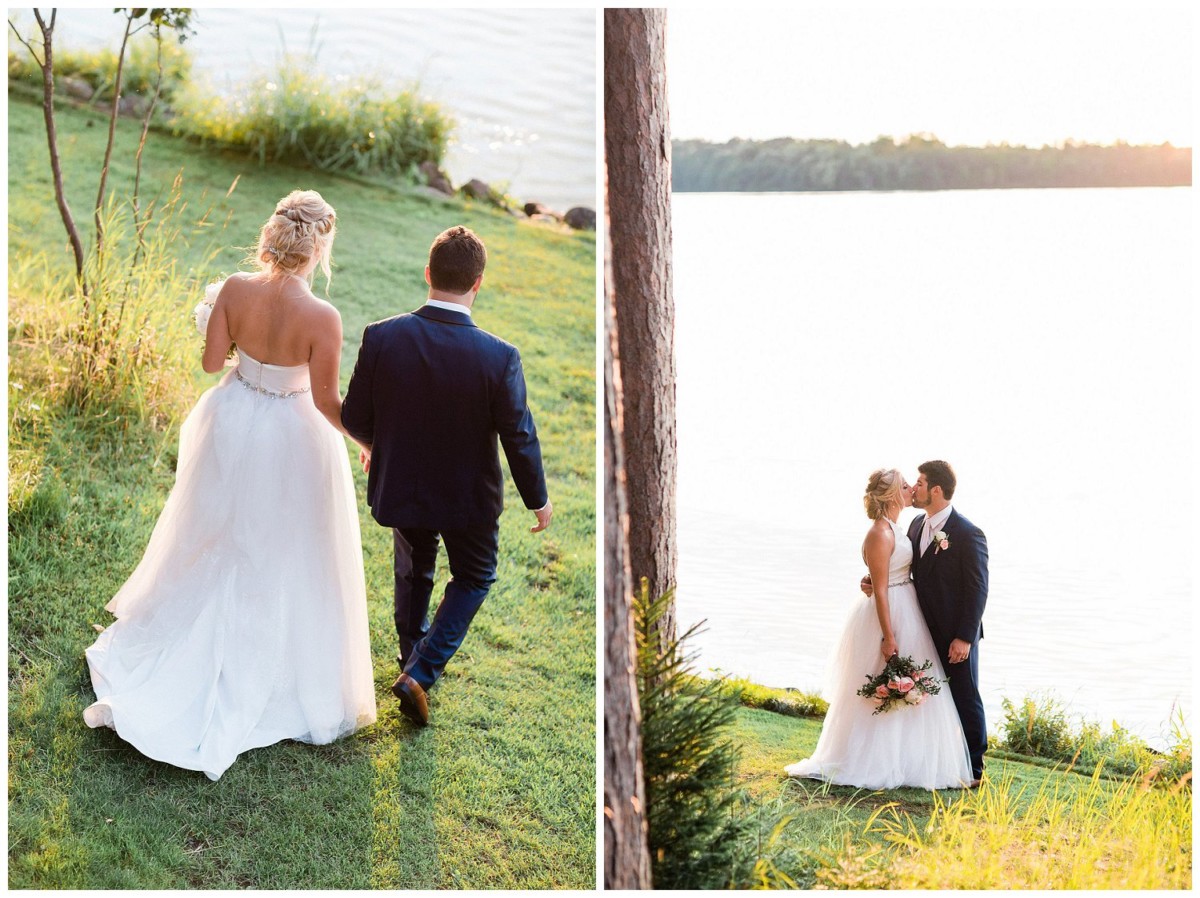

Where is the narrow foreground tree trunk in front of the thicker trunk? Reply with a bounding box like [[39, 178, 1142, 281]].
[[604, 183, 652, 888]]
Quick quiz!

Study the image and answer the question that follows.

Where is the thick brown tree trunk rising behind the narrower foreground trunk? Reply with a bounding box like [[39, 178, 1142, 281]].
[[604, 8, 677, 640]]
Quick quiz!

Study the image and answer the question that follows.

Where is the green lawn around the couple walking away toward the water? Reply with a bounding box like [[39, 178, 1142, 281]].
[[8, 94, 596, 888]]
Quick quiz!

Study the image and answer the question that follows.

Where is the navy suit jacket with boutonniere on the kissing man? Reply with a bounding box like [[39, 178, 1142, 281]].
[[908, 509, 988, 648]]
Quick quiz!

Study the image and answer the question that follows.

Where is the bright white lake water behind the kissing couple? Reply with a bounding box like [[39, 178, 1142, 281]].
[[673, 188, 1198, 743]]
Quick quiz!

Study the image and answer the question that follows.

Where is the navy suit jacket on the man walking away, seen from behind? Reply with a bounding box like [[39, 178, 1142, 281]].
[[342, 306, 547, 531]]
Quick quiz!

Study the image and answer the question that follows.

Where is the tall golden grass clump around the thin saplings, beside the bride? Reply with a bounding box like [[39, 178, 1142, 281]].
[[10, 175, 223, 432]]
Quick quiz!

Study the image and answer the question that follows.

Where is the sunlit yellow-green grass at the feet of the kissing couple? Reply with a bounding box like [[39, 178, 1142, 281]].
[[731, 708, 1192, 888]]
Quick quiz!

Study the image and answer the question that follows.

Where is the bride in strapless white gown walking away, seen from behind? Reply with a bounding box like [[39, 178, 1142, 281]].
[[84, 191, 376, 779]]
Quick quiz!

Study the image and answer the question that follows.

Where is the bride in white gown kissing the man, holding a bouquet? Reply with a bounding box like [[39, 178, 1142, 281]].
[[785, 469, 971, 789]]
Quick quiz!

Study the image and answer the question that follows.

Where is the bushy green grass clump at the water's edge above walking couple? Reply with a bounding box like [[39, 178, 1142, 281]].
[[175, 55, 454, 179]]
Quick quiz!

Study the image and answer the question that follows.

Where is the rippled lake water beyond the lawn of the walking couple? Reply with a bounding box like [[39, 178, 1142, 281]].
[[8, 8, 598, 211]]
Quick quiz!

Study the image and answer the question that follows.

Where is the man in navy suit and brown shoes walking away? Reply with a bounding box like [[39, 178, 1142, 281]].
[[342, 227, 553, 726]]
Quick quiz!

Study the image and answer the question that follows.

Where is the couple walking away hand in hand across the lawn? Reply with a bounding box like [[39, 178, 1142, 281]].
[[84, 191, 553, 780]]
